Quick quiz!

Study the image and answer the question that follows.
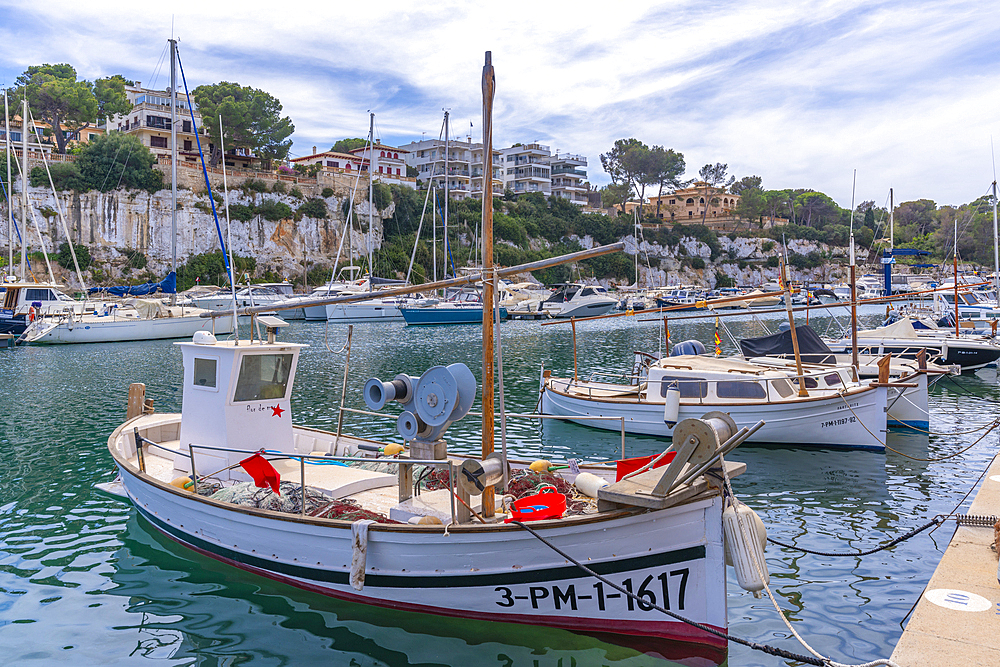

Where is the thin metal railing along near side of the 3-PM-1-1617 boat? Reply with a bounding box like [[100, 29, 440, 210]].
[[134, 428, 459, 524]]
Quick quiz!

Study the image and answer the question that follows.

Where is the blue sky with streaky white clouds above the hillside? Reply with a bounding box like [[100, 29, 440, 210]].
[[0, 0, 1000, 207]]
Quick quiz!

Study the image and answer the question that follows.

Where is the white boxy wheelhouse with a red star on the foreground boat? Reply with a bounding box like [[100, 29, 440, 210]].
[[174, 331, 306, 481]]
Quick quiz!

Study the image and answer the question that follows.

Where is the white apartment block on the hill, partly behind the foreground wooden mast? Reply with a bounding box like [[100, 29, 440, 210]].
[[400, 139, 503, 199]]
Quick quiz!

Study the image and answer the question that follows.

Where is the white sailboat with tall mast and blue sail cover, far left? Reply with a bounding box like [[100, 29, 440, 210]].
[[18, 40, 236, 345]]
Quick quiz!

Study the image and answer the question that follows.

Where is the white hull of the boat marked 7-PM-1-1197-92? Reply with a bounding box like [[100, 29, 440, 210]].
[[541, 378, 886, 450]]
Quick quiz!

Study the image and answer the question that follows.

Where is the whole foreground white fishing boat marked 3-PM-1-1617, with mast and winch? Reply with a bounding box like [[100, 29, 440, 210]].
[[99, 52, 760, 664]]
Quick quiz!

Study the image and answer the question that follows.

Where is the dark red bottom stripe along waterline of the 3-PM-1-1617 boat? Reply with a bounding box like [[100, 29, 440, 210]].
[[160, 524, 728, 665]]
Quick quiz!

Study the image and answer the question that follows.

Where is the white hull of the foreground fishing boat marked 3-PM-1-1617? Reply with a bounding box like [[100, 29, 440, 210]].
[[116, 454, 727, 652]]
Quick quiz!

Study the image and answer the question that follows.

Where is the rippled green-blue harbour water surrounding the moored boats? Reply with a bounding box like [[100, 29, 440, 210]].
[[0, 314, 997, 667]]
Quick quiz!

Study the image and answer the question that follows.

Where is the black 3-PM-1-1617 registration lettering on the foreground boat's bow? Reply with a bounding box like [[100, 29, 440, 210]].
[[494, 567, 691, 611]]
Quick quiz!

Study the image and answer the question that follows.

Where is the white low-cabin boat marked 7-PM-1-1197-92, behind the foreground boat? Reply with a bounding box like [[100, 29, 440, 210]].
[[540, 354, 886, 449]]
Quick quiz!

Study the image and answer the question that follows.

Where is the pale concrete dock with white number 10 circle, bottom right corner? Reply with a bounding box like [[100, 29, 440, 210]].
[[892, 458, 1000, 667]]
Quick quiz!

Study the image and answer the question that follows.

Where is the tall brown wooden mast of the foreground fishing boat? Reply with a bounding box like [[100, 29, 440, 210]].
[[476, 51, 497, 518]]
